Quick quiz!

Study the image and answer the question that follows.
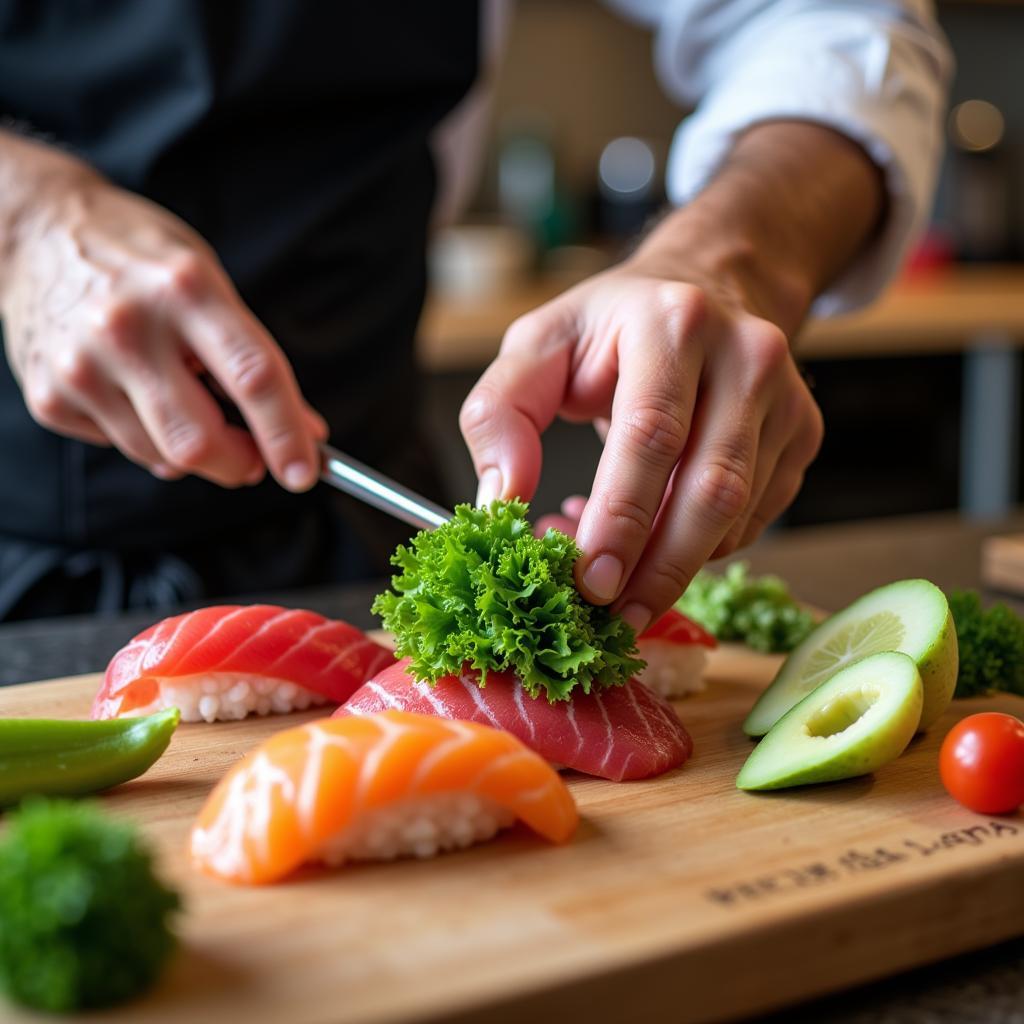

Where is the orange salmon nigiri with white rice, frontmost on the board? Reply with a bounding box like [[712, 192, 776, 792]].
[[190, 711, 578, 885]]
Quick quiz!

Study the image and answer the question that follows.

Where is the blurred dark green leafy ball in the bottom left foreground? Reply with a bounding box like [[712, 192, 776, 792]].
[[0, 798, 179, 1012]]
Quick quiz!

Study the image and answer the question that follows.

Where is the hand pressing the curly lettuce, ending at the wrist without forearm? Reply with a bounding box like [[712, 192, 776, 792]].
[[462, 261, 822, 629]]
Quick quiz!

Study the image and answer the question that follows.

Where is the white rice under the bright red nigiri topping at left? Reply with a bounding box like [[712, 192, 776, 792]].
[[129, 673, 328, 722]]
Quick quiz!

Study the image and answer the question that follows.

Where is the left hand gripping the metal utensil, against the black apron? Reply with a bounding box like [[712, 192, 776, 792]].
[[0, 135, 326, 490]]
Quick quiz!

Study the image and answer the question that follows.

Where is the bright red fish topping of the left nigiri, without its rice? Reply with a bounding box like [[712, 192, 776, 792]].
[[92, 604, 394, 718]]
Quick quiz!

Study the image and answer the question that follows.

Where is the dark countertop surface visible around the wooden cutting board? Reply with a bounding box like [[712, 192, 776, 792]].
[[0, 515, 1024, 1024]]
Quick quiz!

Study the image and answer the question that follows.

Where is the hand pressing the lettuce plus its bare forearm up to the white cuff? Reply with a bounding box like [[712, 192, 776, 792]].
[[461, 123, 882, 631]]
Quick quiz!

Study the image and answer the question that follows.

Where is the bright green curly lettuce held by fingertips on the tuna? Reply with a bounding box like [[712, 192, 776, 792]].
[[373, 501, 644, 701]]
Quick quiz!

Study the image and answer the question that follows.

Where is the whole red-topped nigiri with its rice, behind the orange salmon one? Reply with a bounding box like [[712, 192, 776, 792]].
[[92, 604, 394, 722]]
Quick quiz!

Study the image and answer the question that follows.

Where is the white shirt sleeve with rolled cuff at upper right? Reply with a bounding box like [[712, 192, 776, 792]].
[[608, 0, 952, 315]]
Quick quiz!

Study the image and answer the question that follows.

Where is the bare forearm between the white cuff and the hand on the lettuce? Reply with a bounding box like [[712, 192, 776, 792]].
[[631, 121, 885, 337]]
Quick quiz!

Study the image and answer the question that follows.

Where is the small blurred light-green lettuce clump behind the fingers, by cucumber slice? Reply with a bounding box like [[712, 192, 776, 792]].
[[676, 562, 814, 652]]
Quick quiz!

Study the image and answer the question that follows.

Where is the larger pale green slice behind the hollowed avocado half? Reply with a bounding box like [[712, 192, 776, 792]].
[[743, 580, 957, 736]]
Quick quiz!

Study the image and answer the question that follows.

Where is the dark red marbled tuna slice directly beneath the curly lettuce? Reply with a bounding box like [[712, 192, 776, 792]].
[[335, 658, 693, 781]]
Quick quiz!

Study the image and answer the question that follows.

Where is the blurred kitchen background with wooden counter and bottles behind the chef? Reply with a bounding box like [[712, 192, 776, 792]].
[[420, 0, 1024, 528]]
